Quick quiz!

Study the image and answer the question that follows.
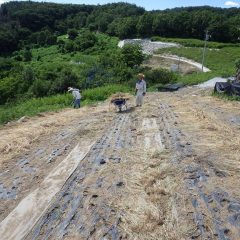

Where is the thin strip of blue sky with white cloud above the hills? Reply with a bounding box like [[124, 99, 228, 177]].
[[0, 0, 240, 10]]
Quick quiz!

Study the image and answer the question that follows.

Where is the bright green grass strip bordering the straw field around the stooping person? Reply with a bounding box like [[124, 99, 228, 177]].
[[0, 85, 130, 124]]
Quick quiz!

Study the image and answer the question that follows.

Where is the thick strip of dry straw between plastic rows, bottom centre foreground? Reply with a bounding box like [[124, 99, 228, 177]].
[[118, 148, 189, 240]]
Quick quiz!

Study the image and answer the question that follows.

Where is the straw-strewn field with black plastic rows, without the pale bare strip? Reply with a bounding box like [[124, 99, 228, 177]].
[[0, 87, 240, 240]]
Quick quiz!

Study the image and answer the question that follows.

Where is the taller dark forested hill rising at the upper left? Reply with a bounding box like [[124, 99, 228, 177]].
[[0, 1, 145, 53]]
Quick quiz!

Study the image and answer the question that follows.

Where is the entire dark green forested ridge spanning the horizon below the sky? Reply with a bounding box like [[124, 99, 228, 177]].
[[0, 1, 240, 53]]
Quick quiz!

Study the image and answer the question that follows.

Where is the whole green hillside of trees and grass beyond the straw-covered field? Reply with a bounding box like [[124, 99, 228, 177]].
[[0, 1, 240, 123]]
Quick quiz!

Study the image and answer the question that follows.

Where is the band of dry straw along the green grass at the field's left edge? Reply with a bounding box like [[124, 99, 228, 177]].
[[0, 104, 107, 165]]
